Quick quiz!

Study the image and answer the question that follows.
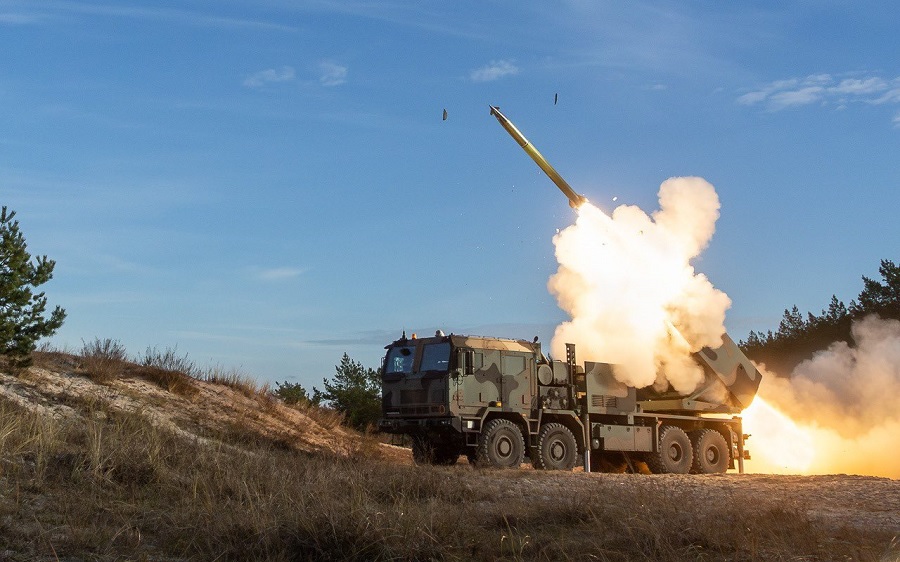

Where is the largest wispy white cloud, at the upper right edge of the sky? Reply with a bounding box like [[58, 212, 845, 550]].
[[736, 74, 900, 122]]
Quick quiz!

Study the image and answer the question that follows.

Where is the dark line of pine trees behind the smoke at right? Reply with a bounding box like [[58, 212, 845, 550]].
[[739, 260, 900, 376]]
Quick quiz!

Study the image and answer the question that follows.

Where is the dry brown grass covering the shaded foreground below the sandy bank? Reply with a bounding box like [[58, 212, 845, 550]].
[[0, 390, 890, 561]]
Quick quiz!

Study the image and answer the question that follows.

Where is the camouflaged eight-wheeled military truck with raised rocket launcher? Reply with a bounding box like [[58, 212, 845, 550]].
[[379, 332, 762, 474]]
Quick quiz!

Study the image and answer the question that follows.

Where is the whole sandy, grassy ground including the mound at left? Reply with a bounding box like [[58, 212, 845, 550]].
[[0, 354, 900, 561]]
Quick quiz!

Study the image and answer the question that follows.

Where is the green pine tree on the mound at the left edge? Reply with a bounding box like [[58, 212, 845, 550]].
[[0, 206, 66, 369]]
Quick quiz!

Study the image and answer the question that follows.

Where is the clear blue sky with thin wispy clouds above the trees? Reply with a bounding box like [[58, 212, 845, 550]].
[[0, 0, 900, 386]]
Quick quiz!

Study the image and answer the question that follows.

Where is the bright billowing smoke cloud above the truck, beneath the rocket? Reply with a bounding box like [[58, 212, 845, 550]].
[[548, 177, 731, 393]]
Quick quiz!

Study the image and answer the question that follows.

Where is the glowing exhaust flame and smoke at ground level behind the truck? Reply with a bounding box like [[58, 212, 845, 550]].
[[744, 316, 900, 478]]
